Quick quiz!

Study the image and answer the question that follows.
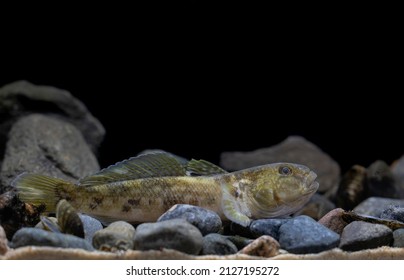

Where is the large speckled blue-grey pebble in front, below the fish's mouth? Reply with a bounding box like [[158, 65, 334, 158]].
[[279, 216, 340, 254]]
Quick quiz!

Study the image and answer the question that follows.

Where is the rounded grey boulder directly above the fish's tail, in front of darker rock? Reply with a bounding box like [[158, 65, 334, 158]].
[[1, 114, 99, 184]]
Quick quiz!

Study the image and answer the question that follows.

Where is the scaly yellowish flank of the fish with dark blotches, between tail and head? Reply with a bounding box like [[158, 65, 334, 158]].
[[72, 177, 224, 223]]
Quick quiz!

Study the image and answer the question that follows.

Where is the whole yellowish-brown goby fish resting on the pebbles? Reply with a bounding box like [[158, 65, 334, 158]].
[[12, 153, 319, 226]]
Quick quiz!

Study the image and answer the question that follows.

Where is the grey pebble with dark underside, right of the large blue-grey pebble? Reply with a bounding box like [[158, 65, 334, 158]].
[[339, 221, 393, 251]]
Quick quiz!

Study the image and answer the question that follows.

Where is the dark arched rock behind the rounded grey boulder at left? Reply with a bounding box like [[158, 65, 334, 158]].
[[0, 81, 105, 152]]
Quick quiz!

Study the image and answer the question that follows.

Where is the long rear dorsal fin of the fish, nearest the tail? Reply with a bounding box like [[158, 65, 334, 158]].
[[79, 153, 186, 187]]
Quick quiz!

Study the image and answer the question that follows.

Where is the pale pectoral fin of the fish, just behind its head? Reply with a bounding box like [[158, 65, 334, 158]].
[[222, 184, 251, 227]]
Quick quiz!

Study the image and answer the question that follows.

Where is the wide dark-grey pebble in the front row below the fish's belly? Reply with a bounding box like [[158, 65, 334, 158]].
[[134, 219, 203, 255]]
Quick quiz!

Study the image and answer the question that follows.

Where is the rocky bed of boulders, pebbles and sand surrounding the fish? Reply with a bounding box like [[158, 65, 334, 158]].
[[0, 82, 404, 259]]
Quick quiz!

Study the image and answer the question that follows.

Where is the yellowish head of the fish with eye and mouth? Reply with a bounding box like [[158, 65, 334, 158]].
[[247, 163, 319, 219]]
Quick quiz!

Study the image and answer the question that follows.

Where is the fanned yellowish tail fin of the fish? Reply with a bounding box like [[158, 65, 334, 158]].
[[11, 173, 74, 213]]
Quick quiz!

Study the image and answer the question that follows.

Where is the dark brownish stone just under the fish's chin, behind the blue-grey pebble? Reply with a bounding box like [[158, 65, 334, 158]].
[[293, 193, 335, 221]]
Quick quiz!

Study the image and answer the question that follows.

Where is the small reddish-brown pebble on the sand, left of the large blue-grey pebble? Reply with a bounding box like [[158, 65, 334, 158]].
[[239, 235, 281, 258]]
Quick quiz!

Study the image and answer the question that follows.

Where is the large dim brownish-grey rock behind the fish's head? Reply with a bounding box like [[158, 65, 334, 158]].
[[220, 136, 340, 193]]
